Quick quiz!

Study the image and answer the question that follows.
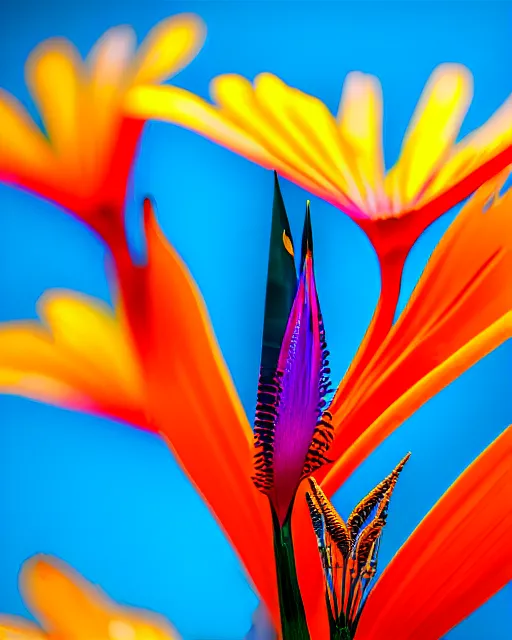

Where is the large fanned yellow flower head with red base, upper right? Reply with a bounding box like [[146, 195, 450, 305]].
[[132, 64, 512, 230]]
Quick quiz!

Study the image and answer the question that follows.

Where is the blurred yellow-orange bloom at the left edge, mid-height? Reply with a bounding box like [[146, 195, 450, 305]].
[[0, 291, 146, 426]]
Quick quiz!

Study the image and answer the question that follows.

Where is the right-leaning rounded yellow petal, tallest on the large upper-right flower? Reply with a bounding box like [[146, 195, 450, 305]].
[[387, 64, 472, 206]]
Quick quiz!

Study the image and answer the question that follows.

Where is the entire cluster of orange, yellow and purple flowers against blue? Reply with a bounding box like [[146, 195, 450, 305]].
[[0, 10, 512, 640]]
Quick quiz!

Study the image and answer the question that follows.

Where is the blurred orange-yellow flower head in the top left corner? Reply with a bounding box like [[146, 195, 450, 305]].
[[0, 14, 204, 248]]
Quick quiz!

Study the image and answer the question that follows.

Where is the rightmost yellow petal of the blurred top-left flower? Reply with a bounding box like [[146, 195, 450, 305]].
[[133, 13, 206, 85]]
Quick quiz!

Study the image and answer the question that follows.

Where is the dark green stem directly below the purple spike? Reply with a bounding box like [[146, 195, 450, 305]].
[[272, 507, 310, 640]]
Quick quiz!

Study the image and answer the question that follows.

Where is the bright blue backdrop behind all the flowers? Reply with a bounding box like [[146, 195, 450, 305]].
[[0, 0, 512, 640]]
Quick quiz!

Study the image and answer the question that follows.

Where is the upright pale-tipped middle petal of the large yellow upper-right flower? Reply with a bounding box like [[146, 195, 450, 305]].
[[338, 72, 389, 216]]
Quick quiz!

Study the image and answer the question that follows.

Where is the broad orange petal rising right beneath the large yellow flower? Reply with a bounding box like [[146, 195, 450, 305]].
[[320, 176, 512, 492]]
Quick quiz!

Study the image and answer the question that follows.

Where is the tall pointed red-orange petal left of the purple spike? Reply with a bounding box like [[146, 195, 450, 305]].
[[136, 201, 277, 619]]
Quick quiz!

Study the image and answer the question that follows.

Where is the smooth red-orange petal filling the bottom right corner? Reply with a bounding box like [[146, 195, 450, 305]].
[[357, 427, 512, 640]]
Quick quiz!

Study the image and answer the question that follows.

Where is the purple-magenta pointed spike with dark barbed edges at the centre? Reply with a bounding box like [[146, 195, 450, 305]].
[[255, 202, 332, 526]]
